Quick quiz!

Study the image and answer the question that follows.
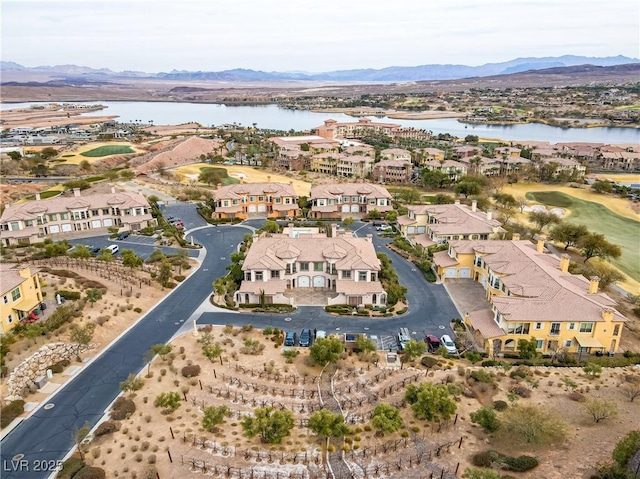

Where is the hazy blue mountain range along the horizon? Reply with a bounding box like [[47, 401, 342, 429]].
[[0, 55, 640, 83]]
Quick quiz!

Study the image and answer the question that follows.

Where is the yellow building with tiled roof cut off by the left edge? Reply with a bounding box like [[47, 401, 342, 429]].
[[0, 263, 42, 334]]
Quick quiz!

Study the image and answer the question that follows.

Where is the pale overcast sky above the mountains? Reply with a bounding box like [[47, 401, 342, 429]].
[[0, 0, 640, 73]]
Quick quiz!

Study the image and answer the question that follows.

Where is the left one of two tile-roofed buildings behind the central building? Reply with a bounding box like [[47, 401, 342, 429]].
[[213, 177, 300, 220]]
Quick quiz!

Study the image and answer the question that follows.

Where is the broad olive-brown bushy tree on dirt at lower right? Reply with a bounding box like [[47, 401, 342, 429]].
[[500, 404, 567, 445]]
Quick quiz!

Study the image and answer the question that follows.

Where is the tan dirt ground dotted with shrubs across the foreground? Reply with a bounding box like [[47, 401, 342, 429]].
[[86, 326, 640, 479]]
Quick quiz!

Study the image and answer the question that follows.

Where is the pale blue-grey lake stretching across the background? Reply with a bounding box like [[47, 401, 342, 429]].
[[0, 101, 640, 144]]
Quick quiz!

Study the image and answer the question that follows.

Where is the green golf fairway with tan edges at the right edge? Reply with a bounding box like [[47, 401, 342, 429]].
[[526, 191, 640, 281]]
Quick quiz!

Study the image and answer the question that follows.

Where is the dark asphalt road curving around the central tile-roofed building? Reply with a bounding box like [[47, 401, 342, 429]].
[[0, 210, 459, 479]]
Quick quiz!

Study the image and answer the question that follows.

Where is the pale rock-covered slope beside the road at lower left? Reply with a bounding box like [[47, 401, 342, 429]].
[[5, 343, 94, 402]]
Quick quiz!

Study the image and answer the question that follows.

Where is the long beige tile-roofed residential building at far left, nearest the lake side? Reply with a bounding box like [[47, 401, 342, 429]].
[[0, 188, 156, 246]]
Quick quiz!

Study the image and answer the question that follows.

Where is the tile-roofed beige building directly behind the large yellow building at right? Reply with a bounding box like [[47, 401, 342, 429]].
[[397, 200, 506, 247]]
